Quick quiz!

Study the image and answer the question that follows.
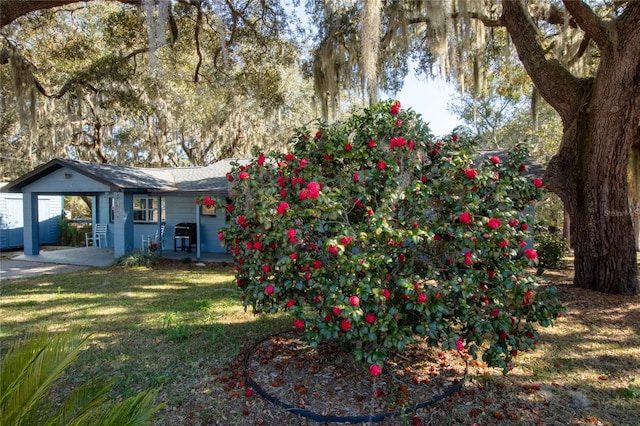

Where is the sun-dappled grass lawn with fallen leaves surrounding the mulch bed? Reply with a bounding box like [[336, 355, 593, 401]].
[[0, 262, 640, 426]]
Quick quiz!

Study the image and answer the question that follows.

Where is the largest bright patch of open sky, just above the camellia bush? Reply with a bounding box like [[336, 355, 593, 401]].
[[381, 73, 463, 136]]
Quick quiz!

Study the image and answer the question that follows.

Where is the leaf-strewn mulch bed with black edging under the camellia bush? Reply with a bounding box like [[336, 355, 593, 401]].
[[246, 332, 467, 422]]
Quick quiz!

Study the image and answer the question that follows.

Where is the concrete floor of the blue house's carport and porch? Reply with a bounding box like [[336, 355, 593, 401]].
[[14, 247, 232, 266]]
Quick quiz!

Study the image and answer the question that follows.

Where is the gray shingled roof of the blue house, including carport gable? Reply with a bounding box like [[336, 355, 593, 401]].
[[2, 158, 248, 195]]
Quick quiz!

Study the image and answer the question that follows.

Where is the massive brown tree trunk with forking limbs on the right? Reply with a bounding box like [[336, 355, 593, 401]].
[[503, 0, 640, 295]]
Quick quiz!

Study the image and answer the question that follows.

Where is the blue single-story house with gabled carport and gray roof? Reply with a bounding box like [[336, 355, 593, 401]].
[[2, 159, 242, 258]]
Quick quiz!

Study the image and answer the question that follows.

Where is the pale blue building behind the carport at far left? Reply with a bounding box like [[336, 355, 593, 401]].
[[0, 183, 64, 250]]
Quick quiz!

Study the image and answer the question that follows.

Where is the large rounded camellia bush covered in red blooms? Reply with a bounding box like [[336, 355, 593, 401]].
[[219, 101, 563, 376]]
